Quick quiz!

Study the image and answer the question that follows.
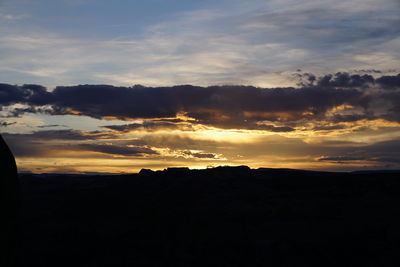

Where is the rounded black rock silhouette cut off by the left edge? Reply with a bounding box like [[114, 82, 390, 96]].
[[0, 135, 19, 267]]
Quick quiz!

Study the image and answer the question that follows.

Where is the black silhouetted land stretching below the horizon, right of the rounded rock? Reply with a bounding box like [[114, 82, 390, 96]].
[[18, 167, 400, 267]]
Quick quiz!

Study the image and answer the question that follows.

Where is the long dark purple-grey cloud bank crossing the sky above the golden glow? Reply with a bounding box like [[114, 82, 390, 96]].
[[0, 73, 400, 132]]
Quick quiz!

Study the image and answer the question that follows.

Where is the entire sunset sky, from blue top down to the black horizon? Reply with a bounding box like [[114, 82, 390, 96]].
[[0, 0, 400, 173]]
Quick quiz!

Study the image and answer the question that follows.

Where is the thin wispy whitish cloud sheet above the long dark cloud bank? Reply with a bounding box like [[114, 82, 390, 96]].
[[0, 0, 400, 86]]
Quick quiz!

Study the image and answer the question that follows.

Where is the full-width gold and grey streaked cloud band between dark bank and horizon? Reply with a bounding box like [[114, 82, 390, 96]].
[[3, 116, 400, 171]]
